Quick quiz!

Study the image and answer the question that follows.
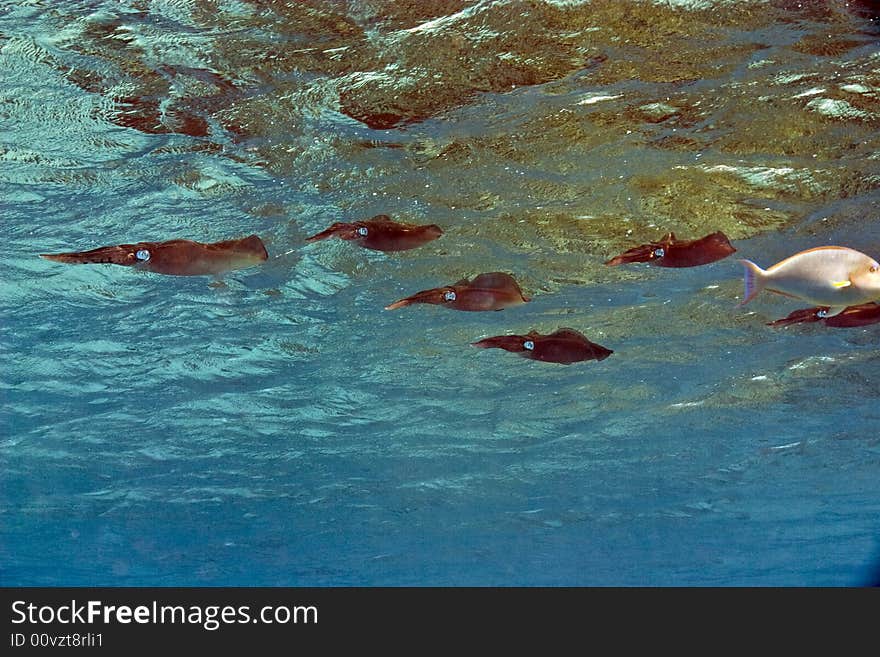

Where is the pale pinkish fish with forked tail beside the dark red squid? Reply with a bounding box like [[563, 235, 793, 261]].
[[740, 246, 880, 317]]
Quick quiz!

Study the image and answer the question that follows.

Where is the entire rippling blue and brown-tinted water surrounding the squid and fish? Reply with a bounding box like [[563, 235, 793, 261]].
[[0, 0, 880, 586]]
